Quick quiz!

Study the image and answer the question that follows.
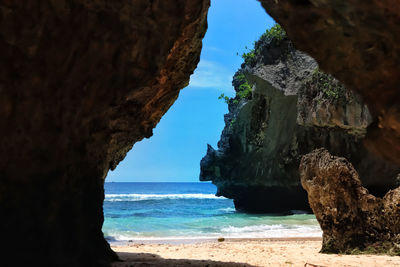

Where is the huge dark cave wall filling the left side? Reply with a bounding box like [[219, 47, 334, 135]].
[[0, 0, 209, 266]]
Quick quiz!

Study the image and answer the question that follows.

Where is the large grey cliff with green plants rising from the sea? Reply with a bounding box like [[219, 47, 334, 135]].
[[200, 39, 400, 213]]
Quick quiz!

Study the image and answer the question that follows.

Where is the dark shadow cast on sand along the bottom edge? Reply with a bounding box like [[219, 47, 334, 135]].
[[112, 252, 253, 267]]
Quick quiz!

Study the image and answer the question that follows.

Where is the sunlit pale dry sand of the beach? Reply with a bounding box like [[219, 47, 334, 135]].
[[113, 238, 400, 267]]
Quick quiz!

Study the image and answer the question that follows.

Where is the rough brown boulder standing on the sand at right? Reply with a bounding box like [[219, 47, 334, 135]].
[[300, 149, 400, 255]]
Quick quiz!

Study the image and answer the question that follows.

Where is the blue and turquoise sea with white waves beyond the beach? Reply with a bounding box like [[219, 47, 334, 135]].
[[103, 183, 322, 241]]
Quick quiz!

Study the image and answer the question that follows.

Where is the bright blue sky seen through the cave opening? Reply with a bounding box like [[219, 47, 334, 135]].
[[106, 0, 274, 182]]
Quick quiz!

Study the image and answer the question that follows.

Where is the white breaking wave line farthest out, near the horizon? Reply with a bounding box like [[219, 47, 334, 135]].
[[105, 194, 225, 201]]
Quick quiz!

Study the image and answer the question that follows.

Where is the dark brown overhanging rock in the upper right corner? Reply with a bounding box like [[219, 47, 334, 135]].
[[260, 0, 400, 165]]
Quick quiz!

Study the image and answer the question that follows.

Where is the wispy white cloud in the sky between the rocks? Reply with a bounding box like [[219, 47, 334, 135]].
[[189, 60, 234, 93]]
